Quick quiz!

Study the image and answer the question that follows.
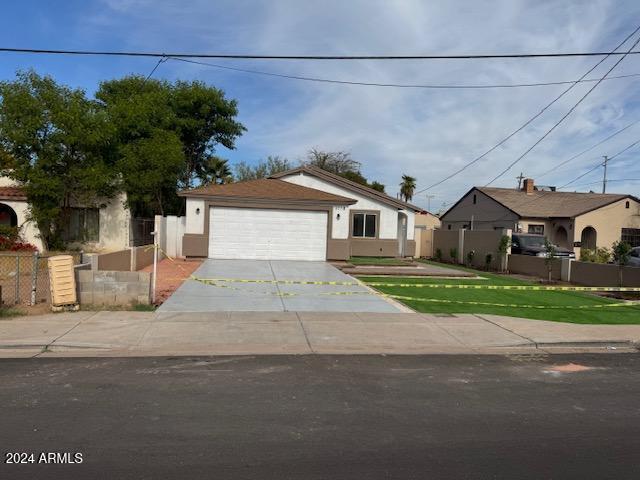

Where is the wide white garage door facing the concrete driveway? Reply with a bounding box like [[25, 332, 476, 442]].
[[209, 207, 327, 260]]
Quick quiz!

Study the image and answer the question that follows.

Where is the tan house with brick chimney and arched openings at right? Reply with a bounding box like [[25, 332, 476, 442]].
[[440, 178, 640, 255]]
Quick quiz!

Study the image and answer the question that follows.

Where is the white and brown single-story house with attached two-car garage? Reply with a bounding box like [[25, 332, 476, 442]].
[[180, 167, 421, 260]]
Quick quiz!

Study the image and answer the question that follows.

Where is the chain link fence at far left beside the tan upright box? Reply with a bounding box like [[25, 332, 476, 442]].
[[0, 252, 80, 306]]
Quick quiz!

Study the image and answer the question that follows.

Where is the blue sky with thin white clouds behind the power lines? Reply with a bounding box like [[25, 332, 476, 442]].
[[0, 0, 640, 211]]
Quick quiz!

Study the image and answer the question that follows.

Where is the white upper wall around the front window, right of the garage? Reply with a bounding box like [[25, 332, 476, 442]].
[[280, 173, 415, 240]]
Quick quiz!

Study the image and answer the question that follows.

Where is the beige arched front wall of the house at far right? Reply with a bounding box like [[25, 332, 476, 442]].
[[574, 198, 640, 256]]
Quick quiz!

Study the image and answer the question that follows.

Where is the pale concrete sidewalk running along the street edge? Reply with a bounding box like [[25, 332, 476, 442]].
[[0, 311, 640, 358]]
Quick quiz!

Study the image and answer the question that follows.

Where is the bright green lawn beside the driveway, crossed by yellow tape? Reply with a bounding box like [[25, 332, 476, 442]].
[[359, 263, 640, 324]]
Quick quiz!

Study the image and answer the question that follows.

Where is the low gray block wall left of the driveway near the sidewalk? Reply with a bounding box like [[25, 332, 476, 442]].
[[76, 270, 151, 305]]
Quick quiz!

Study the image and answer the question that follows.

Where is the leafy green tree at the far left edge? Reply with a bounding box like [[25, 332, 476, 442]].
[[0, 71, 118, 248]]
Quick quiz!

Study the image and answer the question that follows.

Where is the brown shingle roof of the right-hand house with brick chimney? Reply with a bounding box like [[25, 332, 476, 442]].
[[476, 187, 631, 218]]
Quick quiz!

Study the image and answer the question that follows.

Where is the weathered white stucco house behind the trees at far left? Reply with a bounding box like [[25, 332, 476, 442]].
[[0, 177, 131, 251]]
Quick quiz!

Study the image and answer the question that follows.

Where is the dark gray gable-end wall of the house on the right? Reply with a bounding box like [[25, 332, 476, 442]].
[[440, 189, 518, 230]]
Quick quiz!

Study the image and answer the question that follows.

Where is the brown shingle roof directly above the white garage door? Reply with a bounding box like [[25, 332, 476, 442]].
[[180, 178, 356, 205]]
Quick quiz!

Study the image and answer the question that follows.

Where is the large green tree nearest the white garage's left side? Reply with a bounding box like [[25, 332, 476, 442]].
[[96, 76, 244, 215]]
